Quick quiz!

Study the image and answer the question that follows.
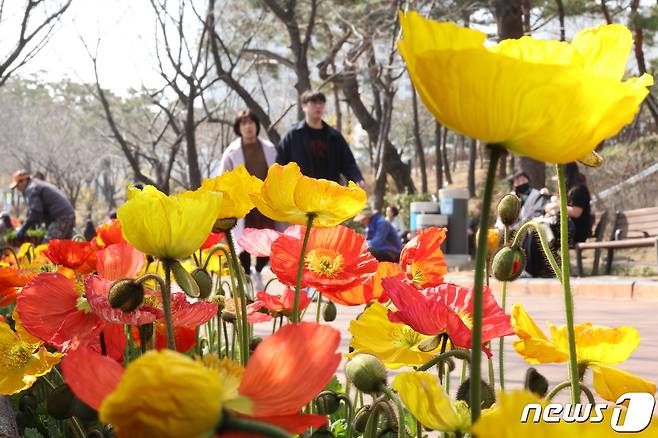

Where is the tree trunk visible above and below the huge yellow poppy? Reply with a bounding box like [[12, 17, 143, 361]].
[[494, 0, 546, 188]]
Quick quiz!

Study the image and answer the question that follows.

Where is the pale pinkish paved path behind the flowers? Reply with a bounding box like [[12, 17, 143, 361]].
[[255, 286, 658, 398]]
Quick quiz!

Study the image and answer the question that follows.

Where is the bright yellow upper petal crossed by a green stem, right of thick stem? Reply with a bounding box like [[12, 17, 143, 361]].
[[549, 323, 640, 365]]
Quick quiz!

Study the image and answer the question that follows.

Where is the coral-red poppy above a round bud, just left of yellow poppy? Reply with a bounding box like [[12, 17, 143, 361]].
[[96, 242, 145, 281]]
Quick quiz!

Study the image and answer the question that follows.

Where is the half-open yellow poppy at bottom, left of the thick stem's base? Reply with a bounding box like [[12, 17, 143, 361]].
[[393, 371, 470, 432]]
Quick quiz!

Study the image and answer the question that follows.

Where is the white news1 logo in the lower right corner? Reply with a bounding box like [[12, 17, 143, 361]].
[[521, 392, 656, 432]]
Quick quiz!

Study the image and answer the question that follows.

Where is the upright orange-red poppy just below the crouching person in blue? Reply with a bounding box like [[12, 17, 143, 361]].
[[400, 227, 448, 288]]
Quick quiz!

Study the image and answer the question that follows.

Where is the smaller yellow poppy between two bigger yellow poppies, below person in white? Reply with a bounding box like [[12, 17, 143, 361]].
[[197, 165, 263, 219]]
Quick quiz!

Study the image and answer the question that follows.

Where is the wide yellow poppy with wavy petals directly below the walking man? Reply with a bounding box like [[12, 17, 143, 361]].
[[250, 163, 366, 227]]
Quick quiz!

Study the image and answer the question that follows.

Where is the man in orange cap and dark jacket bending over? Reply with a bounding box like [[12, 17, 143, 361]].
[[10, 170, 75, 241]]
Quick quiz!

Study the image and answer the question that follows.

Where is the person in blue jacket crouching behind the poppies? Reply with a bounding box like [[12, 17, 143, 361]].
[[354, 207, 402, 263]]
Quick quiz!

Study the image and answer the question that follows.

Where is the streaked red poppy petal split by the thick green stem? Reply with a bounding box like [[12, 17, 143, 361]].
[[425, 283, 514, 343]]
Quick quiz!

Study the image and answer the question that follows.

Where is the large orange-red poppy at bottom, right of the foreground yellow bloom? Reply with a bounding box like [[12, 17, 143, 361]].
[[238, 322, 341, 433]]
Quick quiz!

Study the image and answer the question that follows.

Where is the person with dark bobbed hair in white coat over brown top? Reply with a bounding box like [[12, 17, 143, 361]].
[[219, 109, 276, 290]]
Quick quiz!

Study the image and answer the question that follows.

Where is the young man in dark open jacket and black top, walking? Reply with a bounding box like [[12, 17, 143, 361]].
[[276, 90, 364, 186]]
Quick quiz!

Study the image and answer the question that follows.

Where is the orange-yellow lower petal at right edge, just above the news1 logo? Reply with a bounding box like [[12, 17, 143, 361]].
[[589, 364, 656, 402]]
